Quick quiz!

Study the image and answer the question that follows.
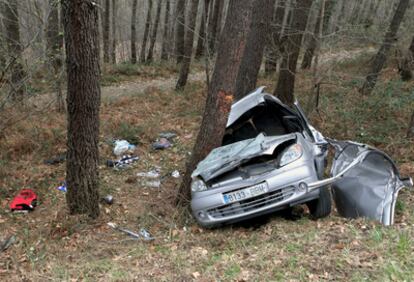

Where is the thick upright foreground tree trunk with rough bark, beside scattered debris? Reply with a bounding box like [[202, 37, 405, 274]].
[[62, 0, 101, 218]]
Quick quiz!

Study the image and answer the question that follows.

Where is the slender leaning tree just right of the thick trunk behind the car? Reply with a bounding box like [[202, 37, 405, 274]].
[[301, 0, 335, 69]]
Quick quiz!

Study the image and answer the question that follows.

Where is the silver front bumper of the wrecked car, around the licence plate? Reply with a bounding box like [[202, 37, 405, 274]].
[[191, 161, 326, 227]]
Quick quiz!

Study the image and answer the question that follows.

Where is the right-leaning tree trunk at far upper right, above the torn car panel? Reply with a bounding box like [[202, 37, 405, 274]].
[[360, 0, 410, 95]]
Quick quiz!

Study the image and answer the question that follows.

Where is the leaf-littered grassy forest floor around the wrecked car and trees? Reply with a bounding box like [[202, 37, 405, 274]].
[[0, 47, 414, 281]]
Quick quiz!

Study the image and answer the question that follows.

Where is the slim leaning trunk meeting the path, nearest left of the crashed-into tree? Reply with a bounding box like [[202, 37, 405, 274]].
[[175, 0, 199, 90]]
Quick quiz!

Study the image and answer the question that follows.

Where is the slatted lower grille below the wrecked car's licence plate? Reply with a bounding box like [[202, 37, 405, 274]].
[[207, 186, 295, 218]]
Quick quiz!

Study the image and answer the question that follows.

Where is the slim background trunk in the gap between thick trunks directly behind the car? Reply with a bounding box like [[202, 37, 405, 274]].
[[265, 0, 289, 74]]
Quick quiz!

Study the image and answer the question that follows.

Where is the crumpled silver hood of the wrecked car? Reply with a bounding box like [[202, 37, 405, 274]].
[[191, 133, 297, 181]]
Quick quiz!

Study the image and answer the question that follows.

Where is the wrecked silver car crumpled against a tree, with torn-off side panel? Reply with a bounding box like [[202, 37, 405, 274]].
[[191, 87, 412, 227]]
